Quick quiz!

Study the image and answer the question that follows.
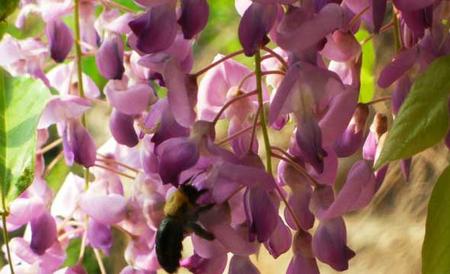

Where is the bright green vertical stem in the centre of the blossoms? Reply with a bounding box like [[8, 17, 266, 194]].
[[255, 50, 272, 175]]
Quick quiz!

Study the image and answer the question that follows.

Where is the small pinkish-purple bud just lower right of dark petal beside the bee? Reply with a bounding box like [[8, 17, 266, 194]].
[[264, 217, 292, 259]]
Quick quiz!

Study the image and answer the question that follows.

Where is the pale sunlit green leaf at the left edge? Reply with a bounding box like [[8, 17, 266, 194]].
[[0, 69, 50, 206]]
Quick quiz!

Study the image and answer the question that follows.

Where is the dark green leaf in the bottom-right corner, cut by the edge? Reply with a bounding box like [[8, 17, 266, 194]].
[[422, 166, 450, 274]]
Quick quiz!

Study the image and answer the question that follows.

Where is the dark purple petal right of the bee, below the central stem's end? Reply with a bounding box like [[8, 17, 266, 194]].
[[244, 187, 278, 242]]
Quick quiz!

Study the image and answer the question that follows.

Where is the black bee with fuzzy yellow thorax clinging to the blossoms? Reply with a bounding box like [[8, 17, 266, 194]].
[[155, 184, 214, 273]]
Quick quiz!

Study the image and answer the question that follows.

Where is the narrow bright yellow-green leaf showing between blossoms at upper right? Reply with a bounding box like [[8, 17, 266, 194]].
[[355, 29, 375, 103]]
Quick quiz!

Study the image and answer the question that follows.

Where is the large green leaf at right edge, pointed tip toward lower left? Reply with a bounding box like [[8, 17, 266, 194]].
[[375, 56, 450, 169]]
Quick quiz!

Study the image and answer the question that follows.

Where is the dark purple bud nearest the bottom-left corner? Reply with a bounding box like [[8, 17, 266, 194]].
[[30, 212, 57, 255]]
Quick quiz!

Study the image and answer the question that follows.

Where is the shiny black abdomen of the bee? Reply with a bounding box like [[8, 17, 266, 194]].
[[156, 217, 184, 273]]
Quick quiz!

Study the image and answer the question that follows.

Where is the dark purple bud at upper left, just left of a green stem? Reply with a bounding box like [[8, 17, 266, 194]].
[[45, 19, 73, 63]]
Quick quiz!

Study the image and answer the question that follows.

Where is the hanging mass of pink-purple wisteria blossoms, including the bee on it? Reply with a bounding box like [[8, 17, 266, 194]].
[[0, 0, 450, 274]]
